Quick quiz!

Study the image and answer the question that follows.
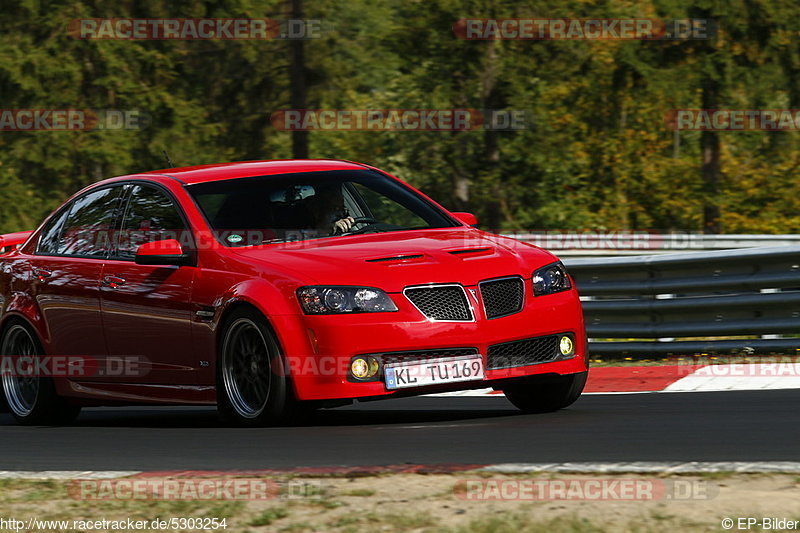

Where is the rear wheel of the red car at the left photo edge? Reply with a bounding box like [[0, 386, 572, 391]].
[[0, 320, 81, 426]]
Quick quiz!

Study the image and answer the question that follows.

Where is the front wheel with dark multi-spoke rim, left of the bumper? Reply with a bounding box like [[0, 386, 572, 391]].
[[217, 309, 291, 426]]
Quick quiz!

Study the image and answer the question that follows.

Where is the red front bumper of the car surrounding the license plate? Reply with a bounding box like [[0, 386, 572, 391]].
[[275, 280, 587, 400]]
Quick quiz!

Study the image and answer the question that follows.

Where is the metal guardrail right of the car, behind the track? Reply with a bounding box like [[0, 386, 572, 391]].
[[564, 246, 800, 355]]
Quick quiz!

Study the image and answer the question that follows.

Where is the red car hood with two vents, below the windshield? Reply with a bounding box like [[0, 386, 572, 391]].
[[234, 228, 556, 292]]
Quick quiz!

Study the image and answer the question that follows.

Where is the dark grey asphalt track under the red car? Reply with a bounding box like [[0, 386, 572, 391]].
[[0, 390, 800, 471]]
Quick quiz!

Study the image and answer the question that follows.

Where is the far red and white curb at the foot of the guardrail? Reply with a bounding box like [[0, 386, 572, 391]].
[[431, 363, 800, 397]]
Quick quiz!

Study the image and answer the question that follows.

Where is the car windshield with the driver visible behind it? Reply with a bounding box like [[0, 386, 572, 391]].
[[187, 170, 456, 246]]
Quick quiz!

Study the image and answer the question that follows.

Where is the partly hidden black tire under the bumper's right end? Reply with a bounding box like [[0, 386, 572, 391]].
[[503, 372, 588, 413]]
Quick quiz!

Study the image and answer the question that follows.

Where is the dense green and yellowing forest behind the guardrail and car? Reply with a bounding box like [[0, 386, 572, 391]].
[[0, 0, 800, 233]]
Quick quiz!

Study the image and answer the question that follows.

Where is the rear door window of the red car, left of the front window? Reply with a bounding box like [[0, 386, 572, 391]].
[[53, 186, 122, 257]]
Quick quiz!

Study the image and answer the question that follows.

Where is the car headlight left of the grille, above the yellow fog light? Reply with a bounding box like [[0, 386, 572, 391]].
[[297, 286, 397, 315]]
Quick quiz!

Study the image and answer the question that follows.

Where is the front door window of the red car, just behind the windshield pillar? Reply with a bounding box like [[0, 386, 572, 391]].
[[116, 185, 188, 260]]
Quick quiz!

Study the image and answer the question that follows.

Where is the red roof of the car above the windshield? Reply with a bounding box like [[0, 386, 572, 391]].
[[140, 159, 370, 185]]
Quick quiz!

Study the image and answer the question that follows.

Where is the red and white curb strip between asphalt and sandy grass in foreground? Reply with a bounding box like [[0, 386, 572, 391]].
[[0, 461, 800, 480]]
